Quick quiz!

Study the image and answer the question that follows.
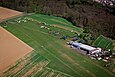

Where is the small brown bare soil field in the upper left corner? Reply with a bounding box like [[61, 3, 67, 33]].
[[0, 7, 23, 21]]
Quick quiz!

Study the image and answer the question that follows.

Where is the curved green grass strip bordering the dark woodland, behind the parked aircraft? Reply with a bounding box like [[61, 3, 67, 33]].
[[29, 14, 83, 33]]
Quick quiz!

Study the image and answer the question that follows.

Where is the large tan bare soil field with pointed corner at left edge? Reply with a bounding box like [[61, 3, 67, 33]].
[[0, 27, 33, 72]]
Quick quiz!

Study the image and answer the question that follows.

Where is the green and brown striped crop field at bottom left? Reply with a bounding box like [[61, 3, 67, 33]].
[[3, 51, 69, 77]]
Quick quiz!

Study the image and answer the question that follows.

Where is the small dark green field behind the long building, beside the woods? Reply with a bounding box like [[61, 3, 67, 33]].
[[92, 35, 113, 49]]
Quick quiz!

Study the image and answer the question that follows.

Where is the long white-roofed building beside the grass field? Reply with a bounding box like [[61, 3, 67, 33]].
[[71, 42, 101, 54]]
